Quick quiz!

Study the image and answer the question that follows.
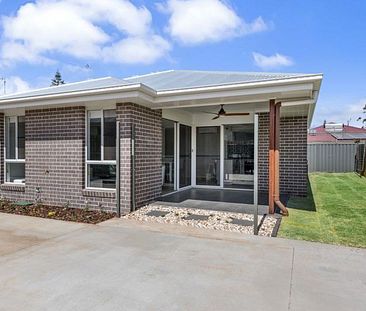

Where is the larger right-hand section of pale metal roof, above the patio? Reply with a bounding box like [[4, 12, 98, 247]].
[[124, 70, 313, 91]]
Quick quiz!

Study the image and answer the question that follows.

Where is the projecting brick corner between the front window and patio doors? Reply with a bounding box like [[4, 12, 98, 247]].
[[116, 103, 162, 212]]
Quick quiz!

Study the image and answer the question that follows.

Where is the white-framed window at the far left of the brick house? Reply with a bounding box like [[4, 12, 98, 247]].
[[5, 116, 25, 184]]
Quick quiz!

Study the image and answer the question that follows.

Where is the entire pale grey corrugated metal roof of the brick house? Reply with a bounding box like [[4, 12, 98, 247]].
[[0, 70, 320, 101]]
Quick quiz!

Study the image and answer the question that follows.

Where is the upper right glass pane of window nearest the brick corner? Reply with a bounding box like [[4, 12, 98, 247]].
[[104, 110, 116, 160]]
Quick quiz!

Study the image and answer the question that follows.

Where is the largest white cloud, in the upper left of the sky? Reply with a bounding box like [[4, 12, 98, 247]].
[[0, 0, 169, 63]]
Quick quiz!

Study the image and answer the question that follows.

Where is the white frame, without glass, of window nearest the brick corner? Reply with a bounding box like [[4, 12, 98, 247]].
[[84, 108, 117, 191]]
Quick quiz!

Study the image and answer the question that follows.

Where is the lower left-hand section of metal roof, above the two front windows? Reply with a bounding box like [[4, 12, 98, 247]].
[[0, 77, 131, 100]]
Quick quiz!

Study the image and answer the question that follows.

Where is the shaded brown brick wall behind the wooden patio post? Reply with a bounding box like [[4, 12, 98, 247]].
[[258, 113, 307, 196]]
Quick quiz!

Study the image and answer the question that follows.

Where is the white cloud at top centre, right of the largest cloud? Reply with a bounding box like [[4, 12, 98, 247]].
[[157, 0, 268, 45]]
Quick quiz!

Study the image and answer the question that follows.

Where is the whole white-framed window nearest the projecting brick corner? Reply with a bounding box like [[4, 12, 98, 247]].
[[86, 110, 116, 189]]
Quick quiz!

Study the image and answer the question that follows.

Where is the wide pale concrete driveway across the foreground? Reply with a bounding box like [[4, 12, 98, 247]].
[[0, 213, 366, 311]]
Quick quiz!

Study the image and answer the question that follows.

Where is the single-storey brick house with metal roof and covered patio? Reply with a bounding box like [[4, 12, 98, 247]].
[[0, 70, 322, 212]]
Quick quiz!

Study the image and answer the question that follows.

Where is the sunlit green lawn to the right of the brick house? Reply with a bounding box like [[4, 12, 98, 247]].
[[278, 173, 366, 247]]
